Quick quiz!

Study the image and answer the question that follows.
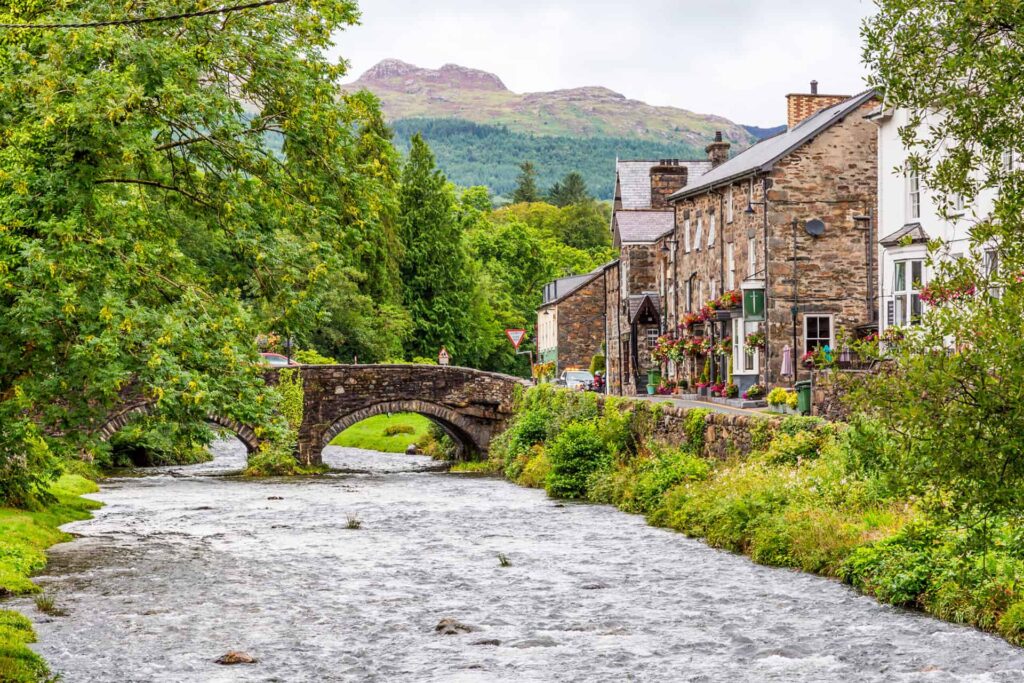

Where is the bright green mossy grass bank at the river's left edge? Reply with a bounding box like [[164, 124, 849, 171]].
[[0, 474, 99, 683]]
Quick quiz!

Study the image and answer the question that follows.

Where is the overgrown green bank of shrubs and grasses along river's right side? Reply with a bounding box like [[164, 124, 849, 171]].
[[488, 386, 1024, 645]]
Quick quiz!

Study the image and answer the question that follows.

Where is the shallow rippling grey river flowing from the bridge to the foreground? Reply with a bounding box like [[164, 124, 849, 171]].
[[12, 441, 1024, 683]]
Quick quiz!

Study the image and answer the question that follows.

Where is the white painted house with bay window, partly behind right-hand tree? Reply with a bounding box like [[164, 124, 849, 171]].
[[867, 109, 997, 333]]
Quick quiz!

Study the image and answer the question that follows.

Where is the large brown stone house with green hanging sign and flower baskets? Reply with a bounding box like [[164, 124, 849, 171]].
[[652, 82, 878, 391]]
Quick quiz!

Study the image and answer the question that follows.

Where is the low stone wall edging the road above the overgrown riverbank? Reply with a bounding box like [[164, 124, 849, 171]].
[[598, 396, 782, 460]]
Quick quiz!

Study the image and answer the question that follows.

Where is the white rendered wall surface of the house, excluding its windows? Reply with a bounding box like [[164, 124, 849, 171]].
[[873, 110, 992, 332]]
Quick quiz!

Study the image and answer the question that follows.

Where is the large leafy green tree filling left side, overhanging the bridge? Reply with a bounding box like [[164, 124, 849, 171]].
[[0, 0, 397, 504]]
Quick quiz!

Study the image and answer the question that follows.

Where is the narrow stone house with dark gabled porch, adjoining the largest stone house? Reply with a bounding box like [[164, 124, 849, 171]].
[[604, 159, 711, 395]]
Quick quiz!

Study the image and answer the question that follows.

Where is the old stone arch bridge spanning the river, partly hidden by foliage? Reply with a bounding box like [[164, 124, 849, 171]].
[[99, 365, 528, 464]]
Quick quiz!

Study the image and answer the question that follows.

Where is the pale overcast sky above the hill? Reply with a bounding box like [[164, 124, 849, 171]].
[[336, 0, 873, 126]]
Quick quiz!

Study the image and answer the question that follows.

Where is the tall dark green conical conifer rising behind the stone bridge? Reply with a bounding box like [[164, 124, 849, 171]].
[[399, 135, 479, 365]]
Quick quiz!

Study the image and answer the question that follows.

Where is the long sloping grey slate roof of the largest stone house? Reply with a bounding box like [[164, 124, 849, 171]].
[[669, 89, 877, 200]]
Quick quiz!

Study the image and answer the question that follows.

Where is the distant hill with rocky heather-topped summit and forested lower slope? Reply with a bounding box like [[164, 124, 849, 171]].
[[343, 59, 759, 199]]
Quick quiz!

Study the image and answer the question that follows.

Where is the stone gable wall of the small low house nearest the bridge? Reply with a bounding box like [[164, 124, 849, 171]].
[[557, 274, 605, 373]]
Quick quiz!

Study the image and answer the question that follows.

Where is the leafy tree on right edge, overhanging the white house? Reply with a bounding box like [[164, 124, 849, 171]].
[[863, 0, 1024, 540]]
